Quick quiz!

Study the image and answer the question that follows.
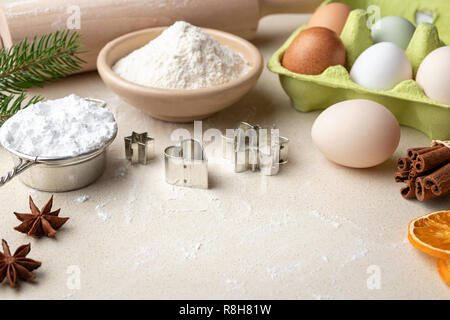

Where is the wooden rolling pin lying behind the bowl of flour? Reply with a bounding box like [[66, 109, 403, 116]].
[[0, 0, 321, 71]]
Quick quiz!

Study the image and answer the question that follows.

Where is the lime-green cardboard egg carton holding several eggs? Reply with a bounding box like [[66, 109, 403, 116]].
[[268, 0, 450, 140]]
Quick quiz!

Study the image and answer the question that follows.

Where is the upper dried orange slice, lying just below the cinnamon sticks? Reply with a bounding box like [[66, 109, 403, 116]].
[[408, 211, 450, 260]]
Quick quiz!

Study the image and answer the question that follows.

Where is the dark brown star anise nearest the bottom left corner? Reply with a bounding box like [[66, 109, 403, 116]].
[[0, 240, 41, 288]]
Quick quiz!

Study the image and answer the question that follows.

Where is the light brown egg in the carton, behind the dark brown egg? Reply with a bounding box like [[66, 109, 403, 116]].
[[307, 2, 352, 35]]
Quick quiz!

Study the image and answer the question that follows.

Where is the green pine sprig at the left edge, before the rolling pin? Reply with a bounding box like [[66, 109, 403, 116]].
[[0, 30, 86, 126]]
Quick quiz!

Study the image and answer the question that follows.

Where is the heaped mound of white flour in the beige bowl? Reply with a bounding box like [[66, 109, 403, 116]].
[[113, 21, 249, 89]]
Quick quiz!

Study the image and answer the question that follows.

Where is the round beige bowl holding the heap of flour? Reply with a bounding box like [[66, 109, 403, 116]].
[[97, 27, 263, 122]]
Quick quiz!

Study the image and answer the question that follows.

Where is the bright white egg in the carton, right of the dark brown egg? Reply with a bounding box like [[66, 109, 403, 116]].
[[350, 42, 413, 90]]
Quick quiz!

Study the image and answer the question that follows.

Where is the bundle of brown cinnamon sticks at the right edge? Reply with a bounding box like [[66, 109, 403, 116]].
[[394, 144, 450, 201]]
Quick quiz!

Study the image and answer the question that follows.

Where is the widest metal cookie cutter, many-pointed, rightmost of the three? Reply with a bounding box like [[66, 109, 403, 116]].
[[222, 122, 289, 176]]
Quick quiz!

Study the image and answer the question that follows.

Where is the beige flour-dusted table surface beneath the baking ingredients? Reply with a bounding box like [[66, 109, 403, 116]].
[[0, 6, 450, 299]]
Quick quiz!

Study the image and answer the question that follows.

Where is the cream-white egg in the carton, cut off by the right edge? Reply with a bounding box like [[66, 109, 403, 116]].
[[416, 46, 450, 104]]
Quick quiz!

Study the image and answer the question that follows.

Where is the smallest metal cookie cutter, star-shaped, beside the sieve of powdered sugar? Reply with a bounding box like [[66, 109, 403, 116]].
[[124, 131, 155, 165]]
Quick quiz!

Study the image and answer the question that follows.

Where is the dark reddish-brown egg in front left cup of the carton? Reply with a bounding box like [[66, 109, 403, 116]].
[[282, 27, 346, 75]]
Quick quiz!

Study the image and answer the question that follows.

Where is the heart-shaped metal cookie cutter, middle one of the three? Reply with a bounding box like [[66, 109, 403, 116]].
[[164, 139, 208, 189]]
